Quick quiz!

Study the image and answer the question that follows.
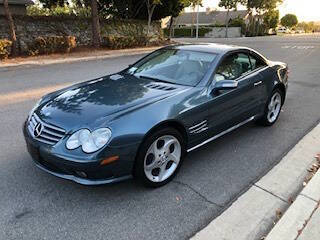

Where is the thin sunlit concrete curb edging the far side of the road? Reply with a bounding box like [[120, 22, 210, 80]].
[[0, 47, 161, 69]]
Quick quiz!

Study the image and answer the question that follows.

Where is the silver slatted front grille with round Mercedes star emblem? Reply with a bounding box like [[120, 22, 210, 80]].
[[28, 113, 66, 145]]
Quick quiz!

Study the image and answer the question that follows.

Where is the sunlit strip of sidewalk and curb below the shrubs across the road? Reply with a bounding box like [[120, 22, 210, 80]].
[[0, 46, 163, 69]]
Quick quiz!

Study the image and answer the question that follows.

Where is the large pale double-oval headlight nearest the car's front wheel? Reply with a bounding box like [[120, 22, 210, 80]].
[[66, 128, 111, 153]]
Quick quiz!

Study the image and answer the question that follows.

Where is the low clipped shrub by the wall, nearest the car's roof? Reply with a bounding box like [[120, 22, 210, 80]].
[[102, 35, 149, 49]]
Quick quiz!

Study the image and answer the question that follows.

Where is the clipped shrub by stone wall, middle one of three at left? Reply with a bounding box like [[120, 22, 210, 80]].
[[28, 36, 77, 55]]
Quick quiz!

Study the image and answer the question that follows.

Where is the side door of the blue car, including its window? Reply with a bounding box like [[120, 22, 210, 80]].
[[208, 51, 261, 135]]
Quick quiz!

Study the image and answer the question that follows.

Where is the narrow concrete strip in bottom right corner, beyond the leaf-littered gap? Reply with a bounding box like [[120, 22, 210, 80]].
[[265, 167, 320, 240]]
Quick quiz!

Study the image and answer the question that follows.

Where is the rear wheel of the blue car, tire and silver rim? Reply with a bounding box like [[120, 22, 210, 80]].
[[256, 88, 284, 127]]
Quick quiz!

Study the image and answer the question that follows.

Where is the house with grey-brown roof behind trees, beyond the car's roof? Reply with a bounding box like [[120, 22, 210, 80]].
[[167, 10, 249, 28]]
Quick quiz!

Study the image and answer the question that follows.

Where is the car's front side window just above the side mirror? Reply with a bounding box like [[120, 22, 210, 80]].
[[215, 53, 251, 81]]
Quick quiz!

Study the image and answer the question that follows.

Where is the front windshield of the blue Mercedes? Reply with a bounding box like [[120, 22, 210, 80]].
[[128, 49, 217, 86]]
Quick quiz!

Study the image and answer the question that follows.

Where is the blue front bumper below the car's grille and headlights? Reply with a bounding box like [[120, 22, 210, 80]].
[[23, 122, 138, 185]]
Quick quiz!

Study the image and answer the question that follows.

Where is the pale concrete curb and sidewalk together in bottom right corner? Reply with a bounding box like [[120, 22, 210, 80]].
[[191, 124, 320, 240]]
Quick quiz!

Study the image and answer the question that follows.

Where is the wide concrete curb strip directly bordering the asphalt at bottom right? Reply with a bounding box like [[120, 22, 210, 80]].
[[192, 124, 320, 240]]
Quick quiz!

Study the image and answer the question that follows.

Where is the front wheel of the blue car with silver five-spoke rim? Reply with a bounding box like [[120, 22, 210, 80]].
[[134, 128, 186, 187]]
